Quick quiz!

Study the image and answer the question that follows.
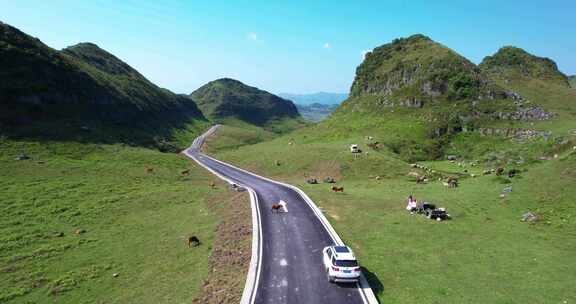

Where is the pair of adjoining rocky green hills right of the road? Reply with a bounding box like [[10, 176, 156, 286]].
[[320, 35, 573, 160]]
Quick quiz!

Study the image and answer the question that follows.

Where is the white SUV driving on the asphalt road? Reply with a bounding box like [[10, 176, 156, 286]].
[[322, 246, 361, 283]]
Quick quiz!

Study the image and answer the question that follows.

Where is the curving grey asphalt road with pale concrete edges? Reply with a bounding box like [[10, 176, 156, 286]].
[[183, 125, 377, 304]]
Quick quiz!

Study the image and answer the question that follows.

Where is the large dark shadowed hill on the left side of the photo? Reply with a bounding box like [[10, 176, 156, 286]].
[[0, 23, 207, 147]]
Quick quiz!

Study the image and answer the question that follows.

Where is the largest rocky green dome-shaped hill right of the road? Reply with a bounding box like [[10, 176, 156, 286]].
[[321, 35, 528, 161]]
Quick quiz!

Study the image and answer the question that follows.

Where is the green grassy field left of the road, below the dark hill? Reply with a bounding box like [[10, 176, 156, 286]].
[[0, 134, 222, 303]]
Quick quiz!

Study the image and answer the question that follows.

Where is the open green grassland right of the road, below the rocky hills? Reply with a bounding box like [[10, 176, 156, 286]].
[[208, 122, 576, 303]]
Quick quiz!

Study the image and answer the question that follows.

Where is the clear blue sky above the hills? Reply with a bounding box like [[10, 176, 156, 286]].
[[0, 0, 576, 93]]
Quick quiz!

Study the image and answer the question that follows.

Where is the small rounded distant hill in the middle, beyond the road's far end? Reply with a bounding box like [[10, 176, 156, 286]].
[[190, 78, 300, 126]]
